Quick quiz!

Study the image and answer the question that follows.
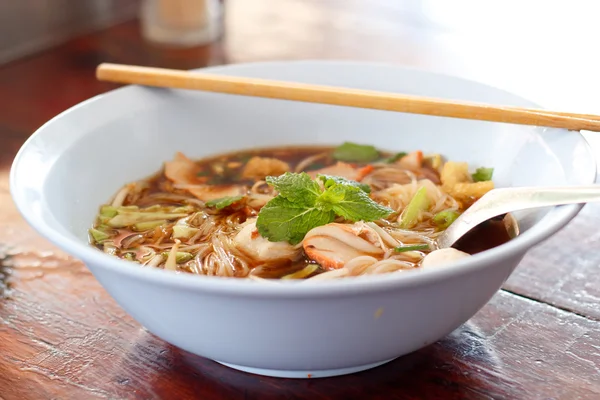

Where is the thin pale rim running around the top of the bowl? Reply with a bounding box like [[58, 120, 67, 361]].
[[9, 60, 597, 298]]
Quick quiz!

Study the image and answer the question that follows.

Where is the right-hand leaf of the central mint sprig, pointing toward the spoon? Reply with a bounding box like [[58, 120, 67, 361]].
[[317, 185, 394, 222]]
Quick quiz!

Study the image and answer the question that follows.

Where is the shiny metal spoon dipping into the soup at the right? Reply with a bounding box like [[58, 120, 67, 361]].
[[437, 185, 600, 249]]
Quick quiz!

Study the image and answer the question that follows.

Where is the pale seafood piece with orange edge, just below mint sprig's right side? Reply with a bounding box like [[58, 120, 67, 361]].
[[302, 223, 384, 270]]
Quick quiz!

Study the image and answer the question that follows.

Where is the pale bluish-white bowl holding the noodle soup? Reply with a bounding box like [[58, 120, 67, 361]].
[[11, 62, 596, 377]]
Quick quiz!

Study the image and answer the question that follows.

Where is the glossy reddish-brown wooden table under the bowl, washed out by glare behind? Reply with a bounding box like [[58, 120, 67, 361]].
[[0, 0, 600, 400]]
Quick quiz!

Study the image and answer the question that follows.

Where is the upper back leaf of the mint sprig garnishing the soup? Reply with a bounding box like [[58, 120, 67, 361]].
[[265, 172, 321, 206]]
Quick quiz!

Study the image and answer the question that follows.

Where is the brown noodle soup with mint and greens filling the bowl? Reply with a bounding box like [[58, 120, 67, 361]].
[[90, 143, 509, 279]]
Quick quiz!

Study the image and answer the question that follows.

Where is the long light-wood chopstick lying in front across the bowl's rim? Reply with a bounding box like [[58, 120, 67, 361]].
[[96, 63, 600, 132]]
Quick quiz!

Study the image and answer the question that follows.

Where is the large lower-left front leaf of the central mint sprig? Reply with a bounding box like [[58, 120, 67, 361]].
[[256, 196, 335, 244]]
